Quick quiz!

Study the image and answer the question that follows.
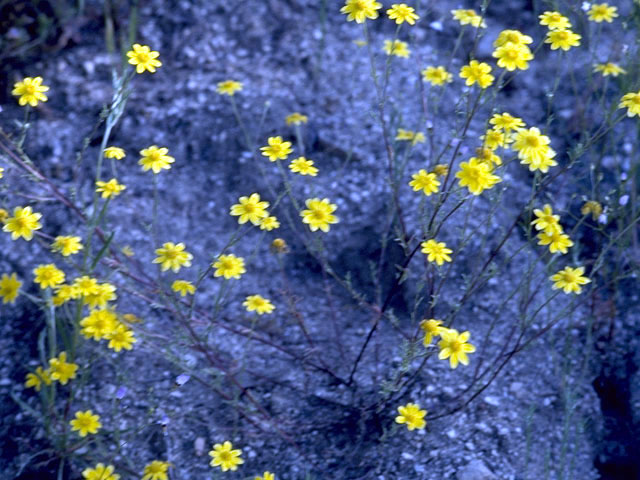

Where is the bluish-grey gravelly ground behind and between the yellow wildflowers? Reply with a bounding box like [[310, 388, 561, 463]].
[[0, 0, 640, 480]]
